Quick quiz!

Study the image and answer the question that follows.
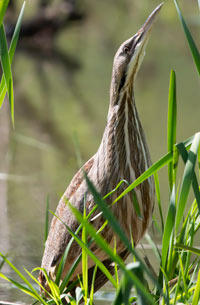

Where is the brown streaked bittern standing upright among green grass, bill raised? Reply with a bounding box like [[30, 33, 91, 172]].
[[39, 4, 162, 290]]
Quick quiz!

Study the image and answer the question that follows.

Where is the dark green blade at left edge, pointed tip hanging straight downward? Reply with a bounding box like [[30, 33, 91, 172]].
[[0, 24, 14, 126]]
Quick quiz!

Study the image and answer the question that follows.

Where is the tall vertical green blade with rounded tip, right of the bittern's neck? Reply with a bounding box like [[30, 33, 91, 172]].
[[167, 70, 177, 190]]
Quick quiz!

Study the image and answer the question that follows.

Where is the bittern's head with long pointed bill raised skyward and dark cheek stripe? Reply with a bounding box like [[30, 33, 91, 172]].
[[110, 3, 163, 104]]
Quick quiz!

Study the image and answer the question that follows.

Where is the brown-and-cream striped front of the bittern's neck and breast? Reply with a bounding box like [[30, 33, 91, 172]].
[[95, 87, 154, 243]]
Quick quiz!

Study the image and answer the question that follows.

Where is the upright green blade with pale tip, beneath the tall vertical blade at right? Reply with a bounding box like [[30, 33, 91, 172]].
[[162, 185, 176, 270]]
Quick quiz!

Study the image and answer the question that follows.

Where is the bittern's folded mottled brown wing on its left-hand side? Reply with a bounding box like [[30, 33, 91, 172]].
[[42, 156, 94, 275]]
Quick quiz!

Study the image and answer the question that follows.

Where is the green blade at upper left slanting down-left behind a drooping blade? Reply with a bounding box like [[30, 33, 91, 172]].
[[0, 2, 25, 108]]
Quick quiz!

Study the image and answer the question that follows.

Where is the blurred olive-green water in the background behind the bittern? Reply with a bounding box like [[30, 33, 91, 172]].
[[0, 0, 200, 304]]
